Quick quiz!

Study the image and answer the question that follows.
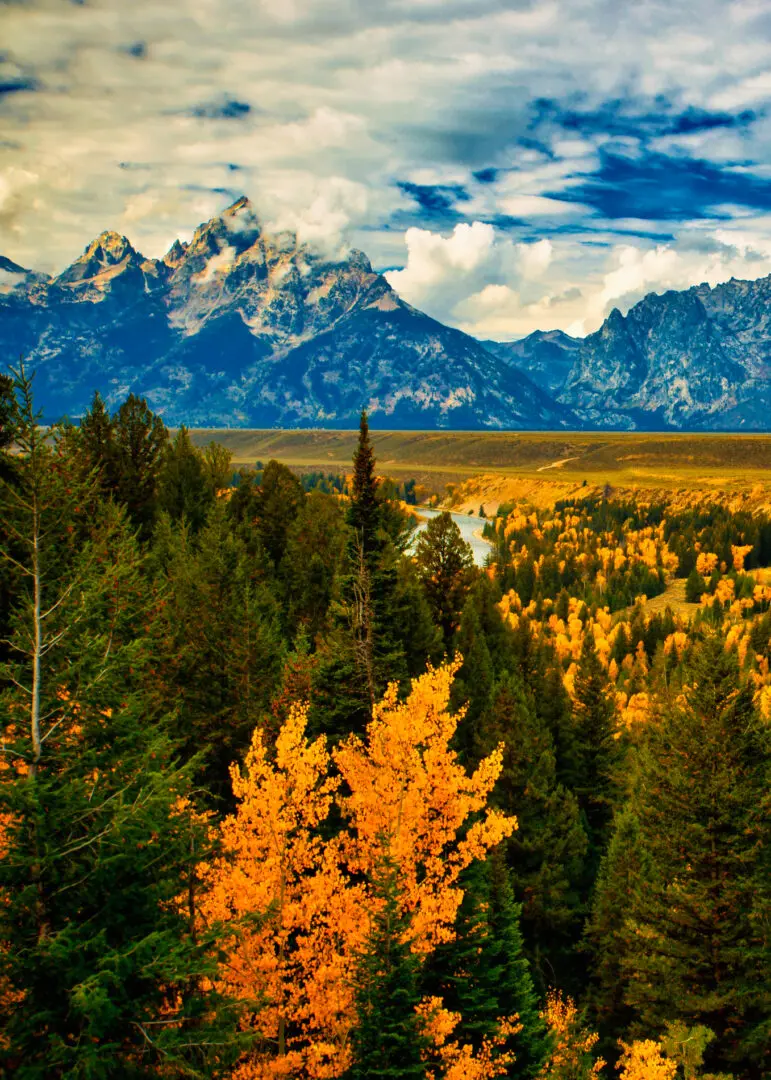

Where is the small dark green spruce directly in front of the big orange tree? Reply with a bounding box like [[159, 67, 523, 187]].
[[348, 856, 428, 1080]]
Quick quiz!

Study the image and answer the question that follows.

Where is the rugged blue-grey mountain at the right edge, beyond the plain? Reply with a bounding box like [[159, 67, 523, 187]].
[[557, 276, 771, 431]]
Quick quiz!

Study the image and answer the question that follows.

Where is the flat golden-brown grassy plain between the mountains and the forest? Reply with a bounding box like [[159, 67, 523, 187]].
[[191, 429, 771, 512]]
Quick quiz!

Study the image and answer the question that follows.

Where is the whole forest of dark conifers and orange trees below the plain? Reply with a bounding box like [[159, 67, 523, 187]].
[[0, 366, 771, 1080]]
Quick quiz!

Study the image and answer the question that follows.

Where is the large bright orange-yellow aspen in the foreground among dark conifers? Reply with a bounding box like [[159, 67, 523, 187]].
[[202, 660, 516, 1080]]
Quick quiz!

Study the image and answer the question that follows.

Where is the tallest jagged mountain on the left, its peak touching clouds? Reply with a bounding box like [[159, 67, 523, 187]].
[[0, 199, 577, 429]]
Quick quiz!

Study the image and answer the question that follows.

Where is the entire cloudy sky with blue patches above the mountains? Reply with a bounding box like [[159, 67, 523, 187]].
[[0, 0, 771, 339]]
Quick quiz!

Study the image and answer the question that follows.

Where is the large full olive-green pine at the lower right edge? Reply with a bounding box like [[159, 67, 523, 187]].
[[619, 635, 771, 1075]]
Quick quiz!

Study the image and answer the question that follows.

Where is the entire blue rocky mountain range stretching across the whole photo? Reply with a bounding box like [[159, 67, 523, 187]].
[[0, 199, 771, 430]]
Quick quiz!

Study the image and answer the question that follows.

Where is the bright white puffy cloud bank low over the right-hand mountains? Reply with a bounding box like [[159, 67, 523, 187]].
[[387, 221, 771, 339]]
